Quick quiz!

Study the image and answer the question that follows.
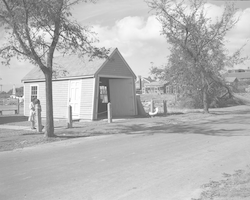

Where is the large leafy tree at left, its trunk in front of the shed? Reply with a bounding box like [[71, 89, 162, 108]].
[[0, 0, 107, 137]]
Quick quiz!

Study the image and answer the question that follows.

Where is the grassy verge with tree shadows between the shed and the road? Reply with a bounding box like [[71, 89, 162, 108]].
[[0, 106, 250, 151]]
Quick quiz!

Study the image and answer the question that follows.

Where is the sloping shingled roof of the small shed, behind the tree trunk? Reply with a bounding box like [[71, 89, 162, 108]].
[[22, 48, 133, 82]]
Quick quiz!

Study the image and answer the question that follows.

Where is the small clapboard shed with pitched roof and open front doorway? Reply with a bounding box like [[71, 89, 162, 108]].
[[22, 48, 137, 120]]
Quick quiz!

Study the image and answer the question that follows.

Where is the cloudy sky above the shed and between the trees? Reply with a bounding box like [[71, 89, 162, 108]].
[[0, 0, 250, 91]]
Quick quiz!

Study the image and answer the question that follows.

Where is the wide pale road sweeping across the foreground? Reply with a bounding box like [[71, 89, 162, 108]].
[[0, 110, 250, 200]]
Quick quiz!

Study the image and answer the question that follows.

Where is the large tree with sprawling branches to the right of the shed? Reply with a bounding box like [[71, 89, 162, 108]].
[[146, 0, 246, 113]]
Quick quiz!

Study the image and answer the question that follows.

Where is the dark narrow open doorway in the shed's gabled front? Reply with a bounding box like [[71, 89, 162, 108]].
[[97, 78, 109, 118]]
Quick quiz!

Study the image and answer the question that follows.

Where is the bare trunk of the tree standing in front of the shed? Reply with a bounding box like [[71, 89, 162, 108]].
[[45, 69, 55, 137]]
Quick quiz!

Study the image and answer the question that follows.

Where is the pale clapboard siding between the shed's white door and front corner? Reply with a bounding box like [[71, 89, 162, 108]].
[[80, 78, 95, 120]]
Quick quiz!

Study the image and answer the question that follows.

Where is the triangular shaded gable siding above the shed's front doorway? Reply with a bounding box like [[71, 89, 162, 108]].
[[98, 52, 133, 77]]
